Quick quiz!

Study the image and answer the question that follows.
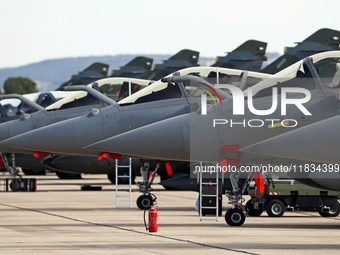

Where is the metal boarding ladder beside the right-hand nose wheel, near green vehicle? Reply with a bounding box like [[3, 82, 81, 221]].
[[197, 162, 223, 221]]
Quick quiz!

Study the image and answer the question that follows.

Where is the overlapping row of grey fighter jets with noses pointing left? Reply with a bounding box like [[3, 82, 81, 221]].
[[0, 29, 340, 225]]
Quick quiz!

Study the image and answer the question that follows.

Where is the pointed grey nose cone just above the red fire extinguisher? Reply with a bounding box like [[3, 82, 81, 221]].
[[86, 116, 189, 160]]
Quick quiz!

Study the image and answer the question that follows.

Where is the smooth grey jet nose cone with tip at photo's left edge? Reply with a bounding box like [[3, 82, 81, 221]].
[[0, 117, 76, 153]]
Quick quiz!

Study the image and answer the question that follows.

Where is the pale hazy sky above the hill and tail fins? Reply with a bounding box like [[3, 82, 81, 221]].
[[0, 0, 340, 68]]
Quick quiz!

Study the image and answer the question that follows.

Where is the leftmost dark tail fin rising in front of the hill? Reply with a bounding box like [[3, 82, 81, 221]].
[[57, 62, 109, 90]]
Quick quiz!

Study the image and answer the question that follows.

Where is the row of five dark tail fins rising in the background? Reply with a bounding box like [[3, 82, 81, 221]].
[[60, 29, 339, 87]]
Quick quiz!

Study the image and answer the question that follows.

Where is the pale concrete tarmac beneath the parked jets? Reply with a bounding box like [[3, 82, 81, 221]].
[[0, 172, 340, 255]]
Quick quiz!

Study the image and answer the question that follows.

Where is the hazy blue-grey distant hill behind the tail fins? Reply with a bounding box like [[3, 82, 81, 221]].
[[0, 53, 278, 91]]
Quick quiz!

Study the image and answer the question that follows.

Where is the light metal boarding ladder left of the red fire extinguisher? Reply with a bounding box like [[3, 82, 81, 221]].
[[115, 158, 132, 208]]
